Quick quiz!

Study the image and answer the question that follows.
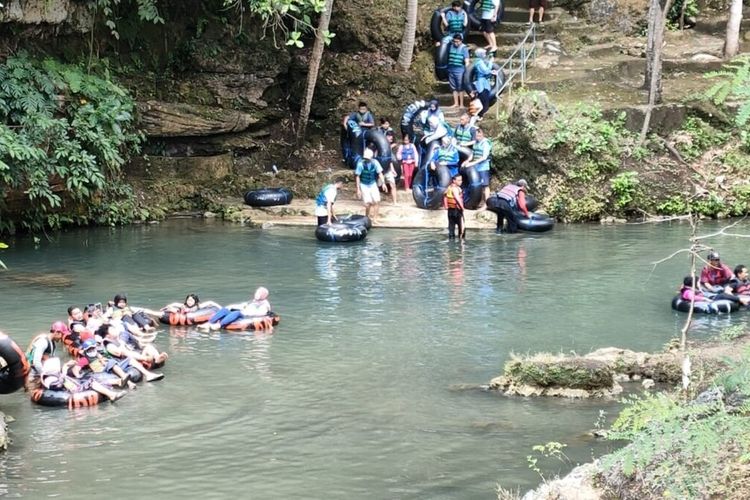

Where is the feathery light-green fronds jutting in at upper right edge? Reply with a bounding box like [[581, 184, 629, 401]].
[[703, 54, 750, 150]]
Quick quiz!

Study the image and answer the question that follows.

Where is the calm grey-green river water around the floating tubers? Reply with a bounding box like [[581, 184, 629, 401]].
[[0, 220, 749, 499]]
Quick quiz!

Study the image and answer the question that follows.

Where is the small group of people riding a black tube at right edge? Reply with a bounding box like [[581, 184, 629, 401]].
[[679, 251, 750, 306]]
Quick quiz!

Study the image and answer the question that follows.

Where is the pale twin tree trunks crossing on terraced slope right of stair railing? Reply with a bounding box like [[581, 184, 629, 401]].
[[639, 0, 672, 144]]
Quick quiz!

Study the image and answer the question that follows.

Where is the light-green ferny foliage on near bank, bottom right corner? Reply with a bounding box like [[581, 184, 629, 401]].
[[602, 394, 750, 498]]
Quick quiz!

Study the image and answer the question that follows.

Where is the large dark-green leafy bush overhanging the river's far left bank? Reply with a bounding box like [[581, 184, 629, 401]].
[[0, 54, 143, 233]]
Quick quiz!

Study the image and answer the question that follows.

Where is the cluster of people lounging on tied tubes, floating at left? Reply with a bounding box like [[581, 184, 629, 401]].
[[26, 287, 272, 407]]
